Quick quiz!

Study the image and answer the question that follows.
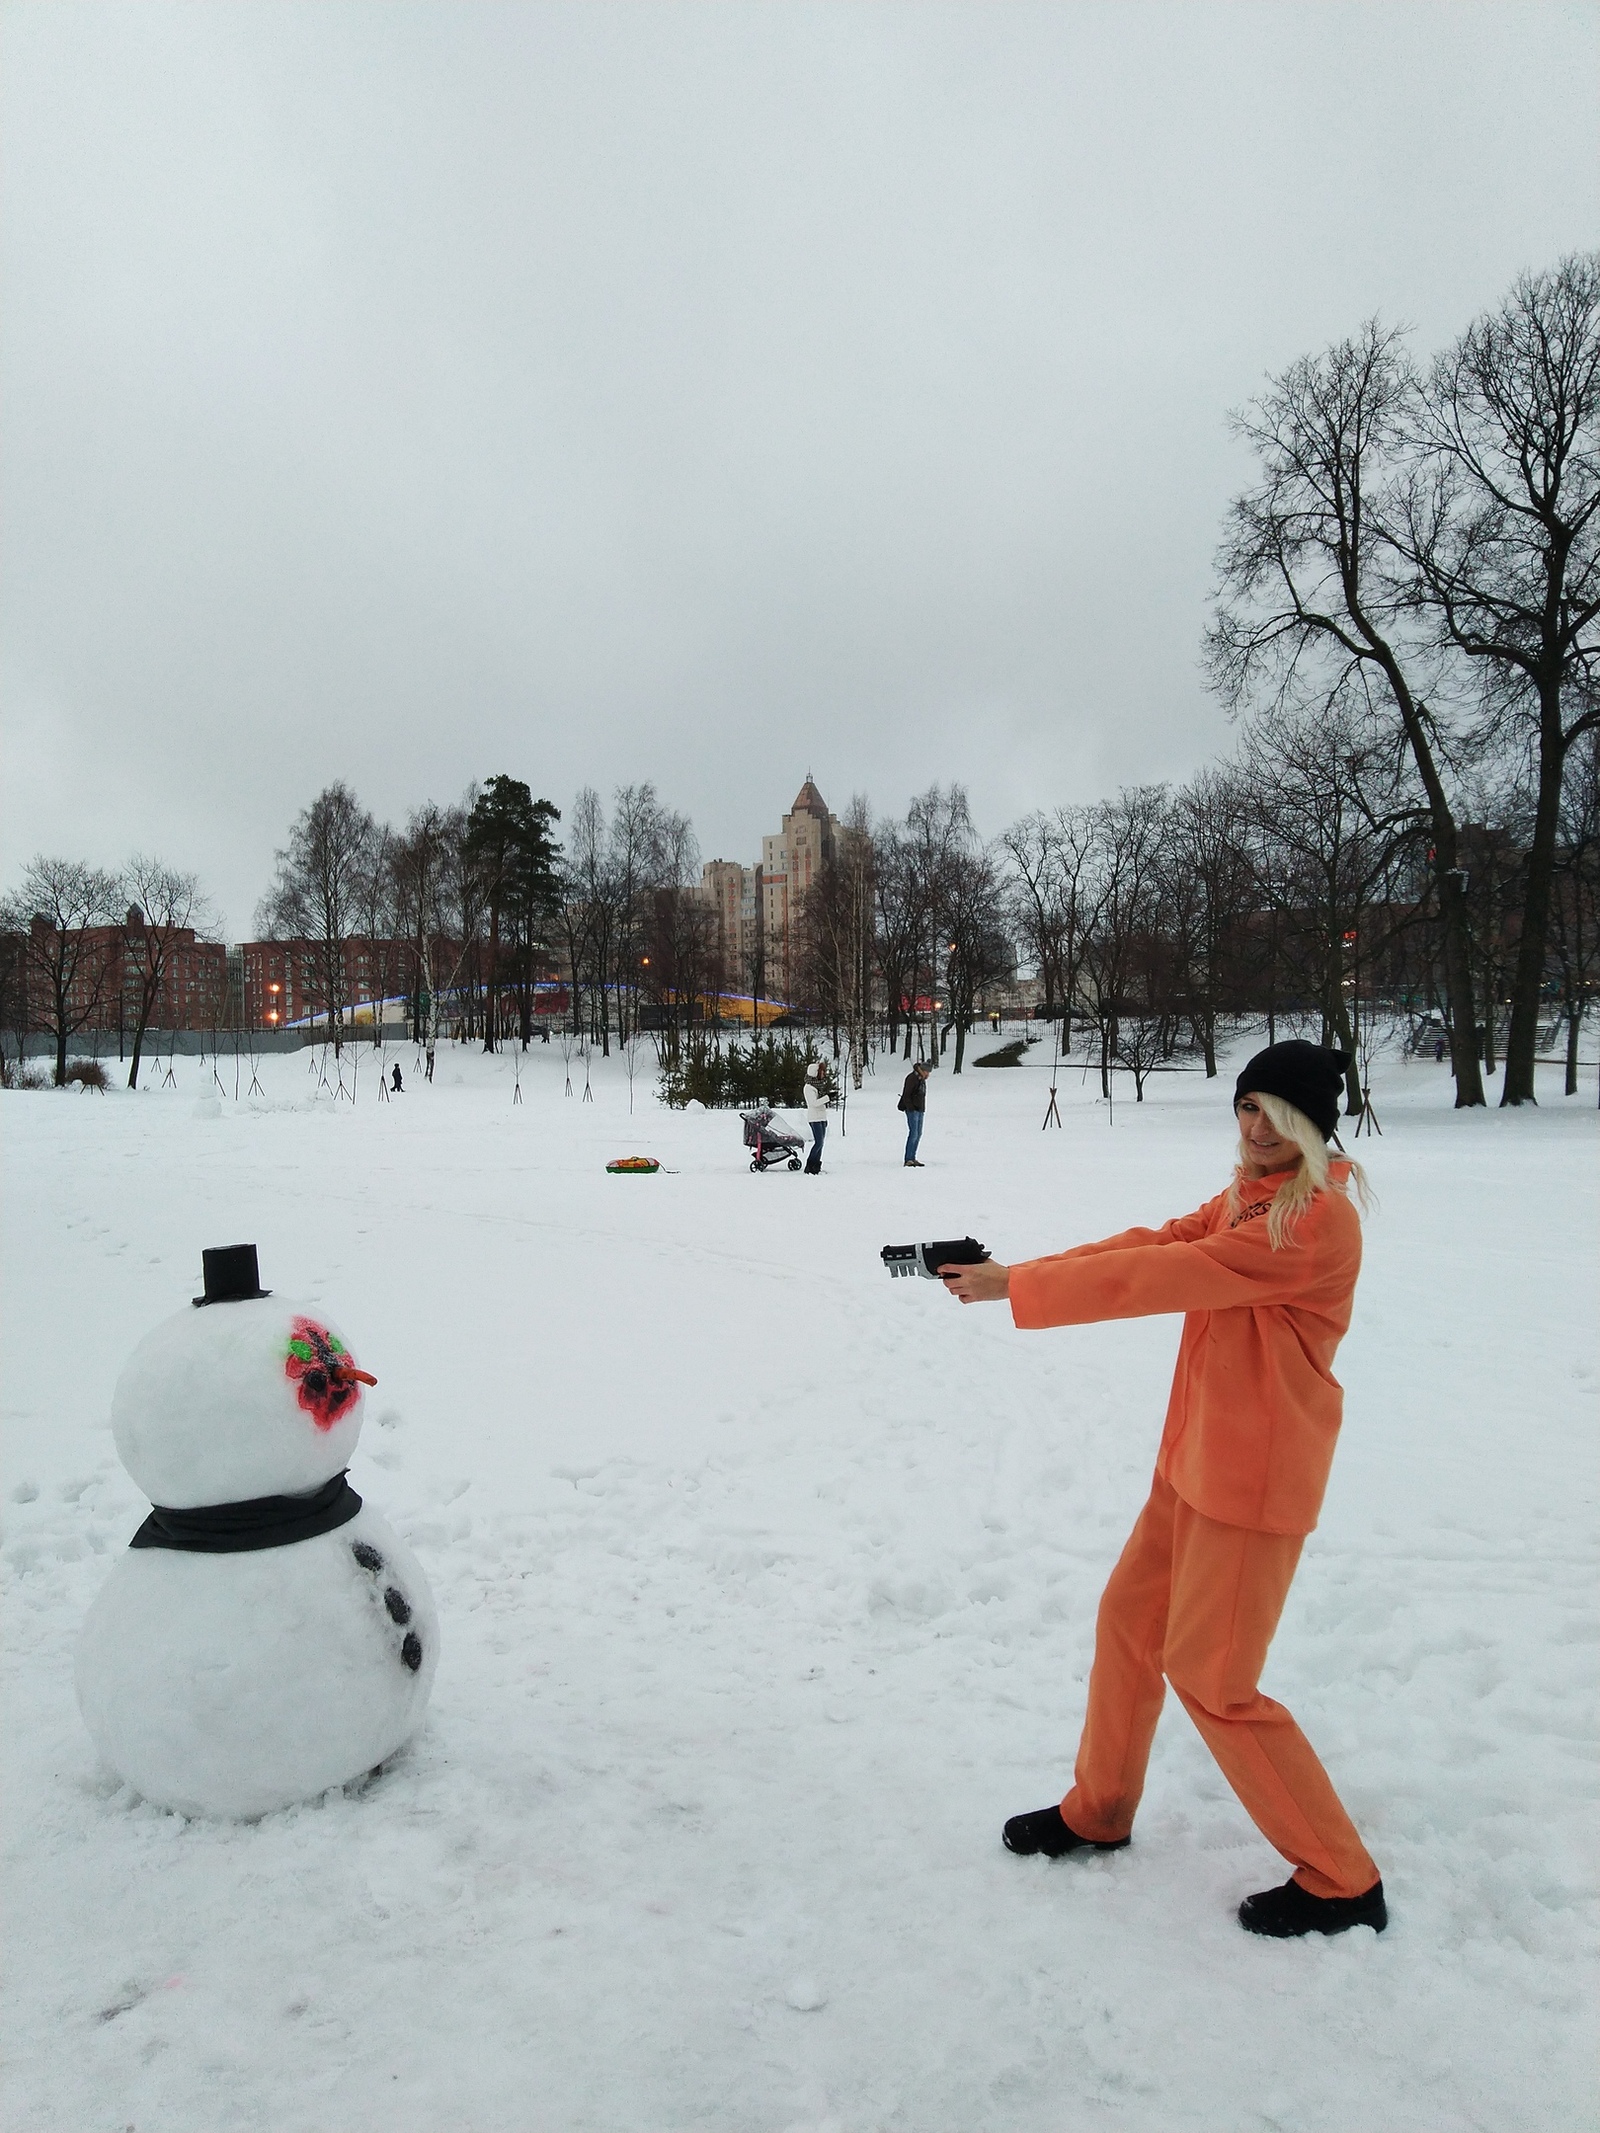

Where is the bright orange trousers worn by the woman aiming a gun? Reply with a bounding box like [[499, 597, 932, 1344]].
[[1060, 1474, 1378, 1896]]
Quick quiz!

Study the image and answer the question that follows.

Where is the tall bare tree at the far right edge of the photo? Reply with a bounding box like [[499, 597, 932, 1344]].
[[1408, 252, 1600, 1103]]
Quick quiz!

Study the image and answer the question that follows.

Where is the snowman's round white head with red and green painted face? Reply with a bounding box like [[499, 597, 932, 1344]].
[[111, 1297, 373, 1510]]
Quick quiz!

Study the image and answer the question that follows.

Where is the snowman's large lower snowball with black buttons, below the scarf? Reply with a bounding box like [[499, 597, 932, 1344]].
[[77, 1504, 439, 1815]]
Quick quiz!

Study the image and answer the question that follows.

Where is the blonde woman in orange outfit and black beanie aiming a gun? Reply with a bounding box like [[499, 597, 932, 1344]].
[[941, 1039, 1389, 1939]]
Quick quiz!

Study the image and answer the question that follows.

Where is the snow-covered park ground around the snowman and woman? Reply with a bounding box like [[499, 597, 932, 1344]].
[[0, 1023, 1600, 2133]]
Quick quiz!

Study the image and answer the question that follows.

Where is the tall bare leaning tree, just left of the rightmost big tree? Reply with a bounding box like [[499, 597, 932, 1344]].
[[1205, 322, 1485, 1105]]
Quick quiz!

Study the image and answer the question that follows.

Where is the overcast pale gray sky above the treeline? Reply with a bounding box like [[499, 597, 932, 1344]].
[[0, 0, 1600, 939]]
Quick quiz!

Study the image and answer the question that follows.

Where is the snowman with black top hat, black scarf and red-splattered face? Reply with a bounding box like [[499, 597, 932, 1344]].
[[77, 1244, 439, 1815]]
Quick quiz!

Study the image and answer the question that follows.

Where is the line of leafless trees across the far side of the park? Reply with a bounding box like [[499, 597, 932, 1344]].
[[0, 254, 1600, 1109]]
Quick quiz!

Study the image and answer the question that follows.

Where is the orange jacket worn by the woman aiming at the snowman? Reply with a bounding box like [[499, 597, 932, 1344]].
[[1011, 1162, 1361, 1534]]
